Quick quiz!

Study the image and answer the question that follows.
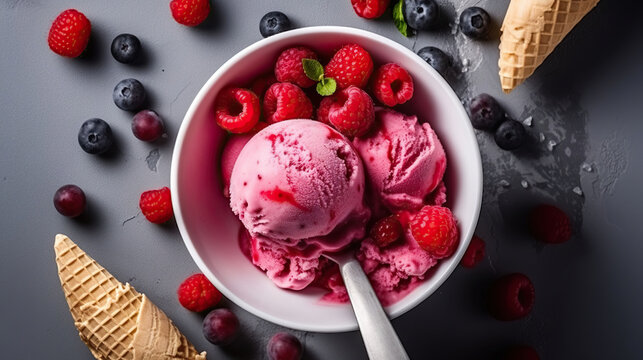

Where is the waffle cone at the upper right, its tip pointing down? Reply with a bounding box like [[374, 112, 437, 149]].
[[498, 0, 599, 93]]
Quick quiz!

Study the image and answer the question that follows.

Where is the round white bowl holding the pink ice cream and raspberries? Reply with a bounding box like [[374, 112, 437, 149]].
[[171, 26, 482, 332]]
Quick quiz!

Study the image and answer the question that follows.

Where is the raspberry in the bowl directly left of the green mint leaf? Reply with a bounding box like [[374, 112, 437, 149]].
[[275, 46, 317, 88]]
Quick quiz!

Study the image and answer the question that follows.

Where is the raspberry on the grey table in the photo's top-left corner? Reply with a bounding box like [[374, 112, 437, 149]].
[[47, 9, 92, 57]]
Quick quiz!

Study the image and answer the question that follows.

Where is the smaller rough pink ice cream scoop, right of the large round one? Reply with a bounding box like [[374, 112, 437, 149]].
[[353, 108, 447, 211]]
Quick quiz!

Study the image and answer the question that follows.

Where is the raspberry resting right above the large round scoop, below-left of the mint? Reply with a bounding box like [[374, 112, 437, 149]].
[[263, 83, 313, 124]]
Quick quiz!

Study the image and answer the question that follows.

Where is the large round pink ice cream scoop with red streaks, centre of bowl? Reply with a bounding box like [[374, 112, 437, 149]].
[[230, 120, 370, 257]]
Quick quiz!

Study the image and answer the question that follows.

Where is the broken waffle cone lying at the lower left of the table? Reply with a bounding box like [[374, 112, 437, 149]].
[[54, 235, 205, 360]]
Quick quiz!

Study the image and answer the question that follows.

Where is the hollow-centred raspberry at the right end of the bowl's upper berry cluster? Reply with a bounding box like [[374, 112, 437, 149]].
[[373, 63, 413, 106]]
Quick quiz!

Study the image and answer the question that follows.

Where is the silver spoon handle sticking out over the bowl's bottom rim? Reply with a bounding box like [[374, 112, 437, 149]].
[[340, 258, 409, 360]]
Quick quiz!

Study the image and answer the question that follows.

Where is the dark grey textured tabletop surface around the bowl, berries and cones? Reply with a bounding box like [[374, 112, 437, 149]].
[[0, 0, 643, 359]]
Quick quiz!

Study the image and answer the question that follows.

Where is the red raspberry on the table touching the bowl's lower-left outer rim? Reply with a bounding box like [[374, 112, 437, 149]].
[[176, 274, 223, 312]]
